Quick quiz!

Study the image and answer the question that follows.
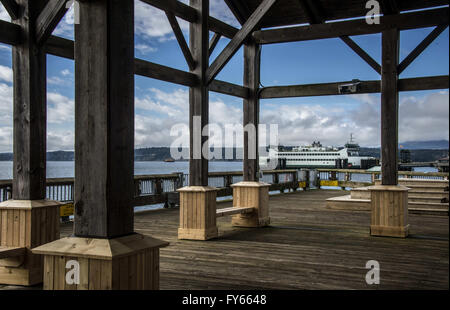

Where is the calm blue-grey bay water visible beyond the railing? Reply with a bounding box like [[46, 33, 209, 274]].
[[0, 161, 242, 180]]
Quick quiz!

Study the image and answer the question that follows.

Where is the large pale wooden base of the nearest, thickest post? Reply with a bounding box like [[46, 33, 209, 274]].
[[33, 233, 168, 290]]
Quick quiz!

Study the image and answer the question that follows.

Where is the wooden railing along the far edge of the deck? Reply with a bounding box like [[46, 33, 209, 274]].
[[0, 169, 449, 212]]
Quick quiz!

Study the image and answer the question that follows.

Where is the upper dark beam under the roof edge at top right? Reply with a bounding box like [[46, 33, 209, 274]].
[[253, 8, 449, 44]]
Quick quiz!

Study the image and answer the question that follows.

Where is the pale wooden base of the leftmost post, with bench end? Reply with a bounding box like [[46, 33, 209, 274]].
[[0, 200, 61, 286]]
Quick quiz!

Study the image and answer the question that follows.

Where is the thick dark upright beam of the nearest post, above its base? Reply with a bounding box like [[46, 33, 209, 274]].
[[74, 0, 134, 238]]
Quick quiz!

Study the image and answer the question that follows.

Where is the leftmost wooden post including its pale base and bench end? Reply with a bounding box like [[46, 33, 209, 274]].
[[0, 0, 60, 286]]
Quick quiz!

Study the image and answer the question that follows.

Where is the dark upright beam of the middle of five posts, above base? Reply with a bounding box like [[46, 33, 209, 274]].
[[189, 0, 209, 186]]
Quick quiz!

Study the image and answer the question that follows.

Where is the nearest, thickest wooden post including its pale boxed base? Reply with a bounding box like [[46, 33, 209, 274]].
[[33, 0, 167, 290]]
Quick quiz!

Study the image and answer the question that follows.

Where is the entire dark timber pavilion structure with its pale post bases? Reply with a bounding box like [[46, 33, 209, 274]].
[[0, 0, 449, 289]]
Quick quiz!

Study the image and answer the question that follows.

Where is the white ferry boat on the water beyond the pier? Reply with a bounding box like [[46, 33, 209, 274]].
[[259, 135, 378, 169]]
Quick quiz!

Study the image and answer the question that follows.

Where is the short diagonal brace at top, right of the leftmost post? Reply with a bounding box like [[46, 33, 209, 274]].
[[36, 0, 68, 44]]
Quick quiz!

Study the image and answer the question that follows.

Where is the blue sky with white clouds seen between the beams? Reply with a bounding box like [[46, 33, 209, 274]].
[[0, 0, 449, 152]]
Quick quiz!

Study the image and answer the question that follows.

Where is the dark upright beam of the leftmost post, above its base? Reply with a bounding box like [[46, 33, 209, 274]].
[[12, 0, 47, 200]]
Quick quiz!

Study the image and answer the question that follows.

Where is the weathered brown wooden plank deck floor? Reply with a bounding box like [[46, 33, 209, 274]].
[[3, 190, 449, 290]]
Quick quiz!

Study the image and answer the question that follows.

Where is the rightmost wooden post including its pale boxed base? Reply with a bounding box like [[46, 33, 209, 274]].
[[370, 29, 409, 237]]
